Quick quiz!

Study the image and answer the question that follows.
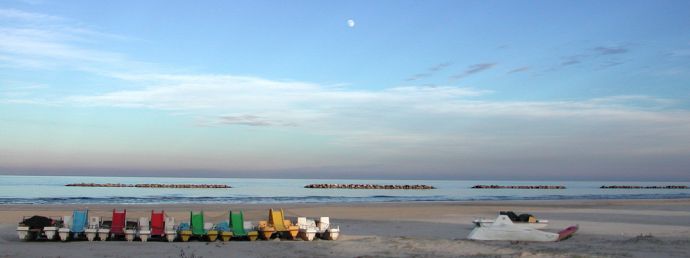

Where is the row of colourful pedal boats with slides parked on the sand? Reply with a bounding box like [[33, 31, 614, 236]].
[[17, 209, 340, 242]]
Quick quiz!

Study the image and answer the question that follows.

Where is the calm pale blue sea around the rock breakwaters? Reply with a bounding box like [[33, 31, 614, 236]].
[[0, 176, 690, 204]]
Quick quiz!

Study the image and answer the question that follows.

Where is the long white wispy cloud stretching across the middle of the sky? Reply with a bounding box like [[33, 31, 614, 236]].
[[67, 74, 489, 125]]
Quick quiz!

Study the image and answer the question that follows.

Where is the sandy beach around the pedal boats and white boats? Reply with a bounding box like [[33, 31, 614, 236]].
[[0, 199, 690, 257]]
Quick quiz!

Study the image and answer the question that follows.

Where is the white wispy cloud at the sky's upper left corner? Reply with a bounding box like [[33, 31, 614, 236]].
[[0, 9, 143, 70]]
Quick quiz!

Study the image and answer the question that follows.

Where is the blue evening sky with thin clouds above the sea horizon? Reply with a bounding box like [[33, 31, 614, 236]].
[[0, 0, 690, 181]]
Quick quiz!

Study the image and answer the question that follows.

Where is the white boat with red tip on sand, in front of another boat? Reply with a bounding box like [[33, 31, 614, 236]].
[[467, 215, 578, 242]]
